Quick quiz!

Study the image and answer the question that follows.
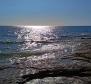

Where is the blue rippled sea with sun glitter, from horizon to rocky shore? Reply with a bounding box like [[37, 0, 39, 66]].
[[0, 25, 91, 84]]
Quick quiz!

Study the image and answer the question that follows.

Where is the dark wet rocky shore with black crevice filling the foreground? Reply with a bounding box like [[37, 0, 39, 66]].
[[0, 39, 91, 84]]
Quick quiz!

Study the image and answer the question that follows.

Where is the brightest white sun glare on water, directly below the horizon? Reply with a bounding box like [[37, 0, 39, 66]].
[[15, 25, 53, 41]]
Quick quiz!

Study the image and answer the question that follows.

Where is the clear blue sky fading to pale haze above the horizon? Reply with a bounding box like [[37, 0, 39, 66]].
[[0, 0, 91, 26]]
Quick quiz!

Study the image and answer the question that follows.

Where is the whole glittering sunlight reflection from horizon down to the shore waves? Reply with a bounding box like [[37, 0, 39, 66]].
[[7, 26, 78, 66]]
